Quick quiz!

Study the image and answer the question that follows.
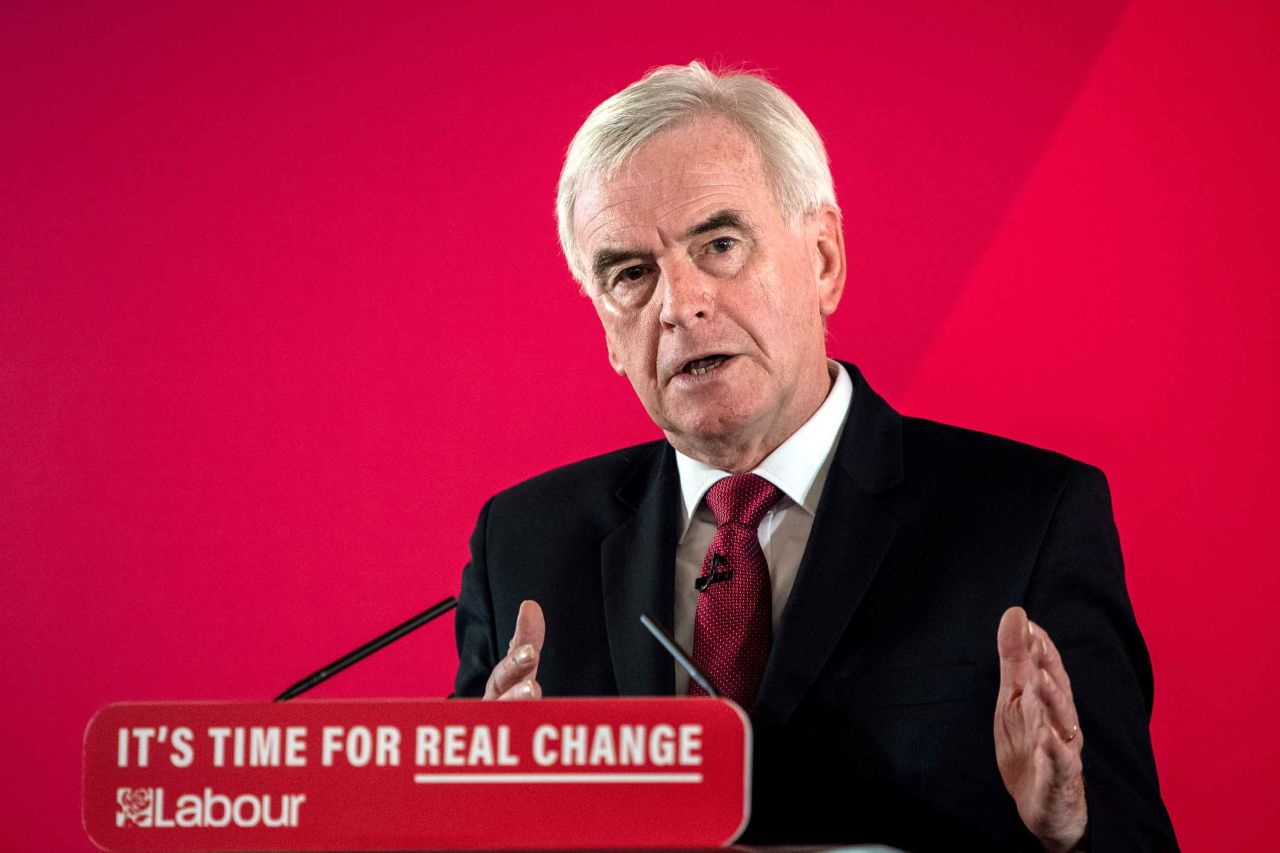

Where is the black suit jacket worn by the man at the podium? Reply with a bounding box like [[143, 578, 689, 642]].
[[457, 365, 1175, 850]]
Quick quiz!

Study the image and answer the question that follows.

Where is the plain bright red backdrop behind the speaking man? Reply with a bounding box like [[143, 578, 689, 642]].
[[0, 0, 1280, 849]]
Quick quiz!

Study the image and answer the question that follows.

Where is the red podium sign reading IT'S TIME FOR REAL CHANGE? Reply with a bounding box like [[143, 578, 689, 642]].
[[83, 698, 751, 852]]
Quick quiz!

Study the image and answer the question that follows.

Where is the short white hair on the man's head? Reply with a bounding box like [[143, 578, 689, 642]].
[[556, 61, 836, 288]]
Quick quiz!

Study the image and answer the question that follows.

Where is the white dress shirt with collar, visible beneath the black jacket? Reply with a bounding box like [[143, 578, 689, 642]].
[[673, 360, 854, 695]]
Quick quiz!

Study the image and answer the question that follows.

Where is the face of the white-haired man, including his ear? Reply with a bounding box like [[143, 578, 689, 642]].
[[573, 117, 845, 470]]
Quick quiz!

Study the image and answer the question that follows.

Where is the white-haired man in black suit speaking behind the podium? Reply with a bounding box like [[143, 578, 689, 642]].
[[457, 63, 1175, 850]]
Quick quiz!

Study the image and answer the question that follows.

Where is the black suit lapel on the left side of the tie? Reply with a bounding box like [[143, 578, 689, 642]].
[[600, 442, 680, 695]]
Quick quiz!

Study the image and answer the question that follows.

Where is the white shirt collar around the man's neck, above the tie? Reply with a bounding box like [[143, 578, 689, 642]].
[[676, 359, 854, 540]]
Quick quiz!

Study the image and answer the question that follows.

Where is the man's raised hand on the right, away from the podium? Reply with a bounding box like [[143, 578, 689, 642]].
[[995, 607, 1088, 850]]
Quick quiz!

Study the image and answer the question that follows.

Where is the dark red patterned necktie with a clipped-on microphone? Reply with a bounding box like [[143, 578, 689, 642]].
[[689, 474, 782, 712]]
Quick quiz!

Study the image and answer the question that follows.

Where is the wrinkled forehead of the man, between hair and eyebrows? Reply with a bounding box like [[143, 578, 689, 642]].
[[573, 118, 777, 254]]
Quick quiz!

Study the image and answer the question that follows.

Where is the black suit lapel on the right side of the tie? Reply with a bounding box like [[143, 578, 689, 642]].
[[754, 364, 902, 725]]
